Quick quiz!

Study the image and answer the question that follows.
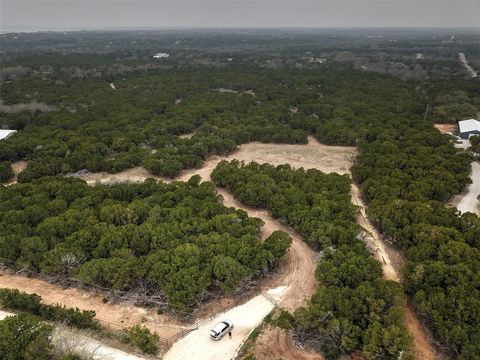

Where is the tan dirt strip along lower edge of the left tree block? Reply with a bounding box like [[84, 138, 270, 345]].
[[0, 272, 186, 338]]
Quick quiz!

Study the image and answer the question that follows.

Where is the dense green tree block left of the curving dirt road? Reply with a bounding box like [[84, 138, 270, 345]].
[[0, 176, 291, 312]]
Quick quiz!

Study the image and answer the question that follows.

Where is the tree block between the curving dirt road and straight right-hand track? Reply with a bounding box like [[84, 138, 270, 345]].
[[212, 160, 411, 359]]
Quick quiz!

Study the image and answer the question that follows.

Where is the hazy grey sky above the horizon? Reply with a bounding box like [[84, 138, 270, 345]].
[[0, 0, 480, 31]]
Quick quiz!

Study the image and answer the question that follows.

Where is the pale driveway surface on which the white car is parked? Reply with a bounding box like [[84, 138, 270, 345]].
[[163, 295, 274, 360]]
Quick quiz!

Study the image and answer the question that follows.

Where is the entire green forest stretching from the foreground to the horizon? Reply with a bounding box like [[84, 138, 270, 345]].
[[0, 34, 480, 359]]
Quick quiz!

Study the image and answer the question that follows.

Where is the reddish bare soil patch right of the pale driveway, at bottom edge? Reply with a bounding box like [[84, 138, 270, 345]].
[[251, 327, 324, 360]]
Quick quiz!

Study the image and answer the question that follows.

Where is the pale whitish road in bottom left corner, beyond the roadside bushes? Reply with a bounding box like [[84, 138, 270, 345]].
[[0, 310, 144, 360]]
